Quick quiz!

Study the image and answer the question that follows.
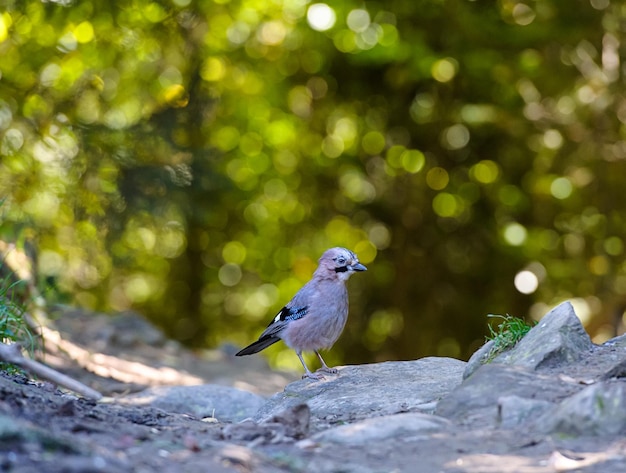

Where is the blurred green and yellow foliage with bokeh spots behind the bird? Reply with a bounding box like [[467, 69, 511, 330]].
[[0, 0, 626, 366]]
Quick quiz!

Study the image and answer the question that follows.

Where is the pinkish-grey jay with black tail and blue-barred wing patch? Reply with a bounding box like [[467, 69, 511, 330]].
[[235, 247, 367, 379]]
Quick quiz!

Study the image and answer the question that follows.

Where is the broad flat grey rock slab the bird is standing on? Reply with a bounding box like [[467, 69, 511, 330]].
[[255, 358, 465, 431]]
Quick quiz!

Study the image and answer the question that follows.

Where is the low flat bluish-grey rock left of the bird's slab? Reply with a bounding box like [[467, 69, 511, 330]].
[[120, 384, 265, 422]]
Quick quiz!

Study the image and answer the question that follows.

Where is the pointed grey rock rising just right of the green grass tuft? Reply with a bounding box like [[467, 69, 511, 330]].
[[463, 302, 594, 378]]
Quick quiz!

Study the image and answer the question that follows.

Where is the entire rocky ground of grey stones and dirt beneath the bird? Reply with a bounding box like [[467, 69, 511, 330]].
[[0, 303, 626, 473]]
